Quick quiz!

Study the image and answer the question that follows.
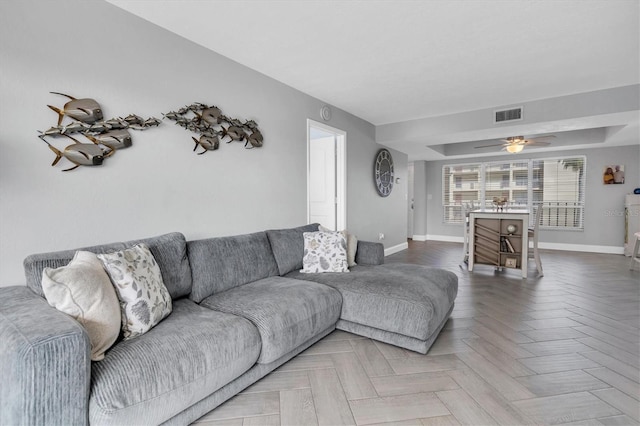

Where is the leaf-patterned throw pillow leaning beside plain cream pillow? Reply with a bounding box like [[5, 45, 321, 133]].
[[98, 243, 172, 340]]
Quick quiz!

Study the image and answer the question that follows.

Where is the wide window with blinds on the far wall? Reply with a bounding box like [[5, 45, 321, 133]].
[[442, 156, 586, 230]]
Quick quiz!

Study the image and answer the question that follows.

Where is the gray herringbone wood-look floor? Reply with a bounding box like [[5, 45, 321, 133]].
[[196, 241, 640, 426]]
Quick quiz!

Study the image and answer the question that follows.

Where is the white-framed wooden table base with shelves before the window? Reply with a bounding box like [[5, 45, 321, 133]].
[[469, 209, 529, 278]]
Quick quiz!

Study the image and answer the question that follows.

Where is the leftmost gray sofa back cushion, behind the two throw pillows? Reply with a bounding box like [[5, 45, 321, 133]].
[[24, 232, 191, 299]]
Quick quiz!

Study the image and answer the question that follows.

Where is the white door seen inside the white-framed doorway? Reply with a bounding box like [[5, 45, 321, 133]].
[[309, 136, 336, 231]]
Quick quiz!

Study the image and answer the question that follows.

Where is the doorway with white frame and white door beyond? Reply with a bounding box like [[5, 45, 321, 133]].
[[307, 119, 347, 231]]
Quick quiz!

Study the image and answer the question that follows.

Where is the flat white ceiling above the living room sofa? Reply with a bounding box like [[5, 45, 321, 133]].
[[107, 0, 640, 158]]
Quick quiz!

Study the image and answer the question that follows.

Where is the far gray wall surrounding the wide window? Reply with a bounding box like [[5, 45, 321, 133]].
[[415, 145, 640, 248]]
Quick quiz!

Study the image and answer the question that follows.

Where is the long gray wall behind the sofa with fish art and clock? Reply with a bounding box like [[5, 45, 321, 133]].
[[0, 0, 407, 286]]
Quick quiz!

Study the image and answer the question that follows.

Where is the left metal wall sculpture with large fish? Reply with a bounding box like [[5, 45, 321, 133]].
[[38, 92, 161, 172]]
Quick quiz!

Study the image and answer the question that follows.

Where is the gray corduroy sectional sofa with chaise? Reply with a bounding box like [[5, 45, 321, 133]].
[[0, 224, 458, 425]]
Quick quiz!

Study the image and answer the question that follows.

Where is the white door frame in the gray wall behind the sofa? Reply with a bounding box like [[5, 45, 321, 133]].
[[307, 118, 347, 231]]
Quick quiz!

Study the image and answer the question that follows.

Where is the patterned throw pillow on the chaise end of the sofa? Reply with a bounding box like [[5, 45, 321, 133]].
[[300, 232, 349, 274]]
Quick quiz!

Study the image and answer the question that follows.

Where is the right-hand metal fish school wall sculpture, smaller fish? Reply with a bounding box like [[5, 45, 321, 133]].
[[163, 102, 263, 155]]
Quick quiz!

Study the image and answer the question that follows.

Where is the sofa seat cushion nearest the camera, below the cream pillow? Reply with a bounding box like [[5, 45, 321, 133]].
[[89, 299, 261, 424]]
